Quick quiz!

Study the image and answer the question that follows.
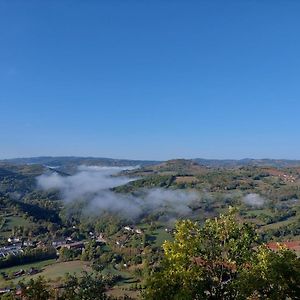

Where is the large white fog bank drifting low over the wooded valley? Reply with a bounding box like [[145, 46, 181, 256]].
[[37, 166, 199, 218]]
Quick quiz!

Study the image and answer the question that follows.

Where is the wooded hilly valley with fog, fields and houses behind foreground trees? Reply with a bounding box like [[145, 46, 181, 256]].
[[0, 159, 300, 298]]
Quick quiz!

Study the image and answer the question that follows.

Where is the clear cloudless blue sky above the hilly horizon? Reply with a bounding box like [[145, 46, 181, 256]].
[[0, 0, 300, 159]]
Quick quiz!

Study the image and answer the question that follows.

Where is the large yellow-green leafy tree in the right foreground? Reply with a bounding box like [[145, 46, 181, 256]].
[[144, 209, 300, 300]]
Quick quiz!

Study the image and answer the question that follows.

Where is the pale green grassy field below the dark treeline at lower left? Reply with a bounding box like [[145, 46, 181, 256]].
[[0, 259, 92, 287]]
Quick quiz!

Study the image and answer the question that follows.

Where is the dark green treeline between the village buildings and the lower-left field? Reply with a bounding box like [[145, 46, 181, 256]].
[[0, 247, 56, 268]]
